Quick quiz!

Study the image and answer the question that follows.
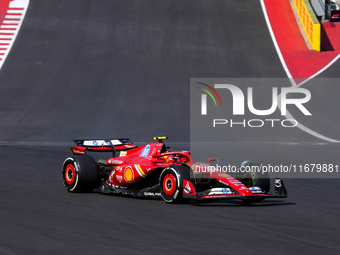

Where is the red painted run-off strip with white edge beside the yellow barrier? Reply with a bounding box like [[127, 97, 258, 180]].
[[263, 0, 340, 85]]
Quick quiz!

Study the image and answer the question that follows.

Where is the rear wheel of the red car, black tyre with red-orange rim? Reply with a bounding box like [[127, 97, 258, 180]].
[[61, 155, 99, 192]]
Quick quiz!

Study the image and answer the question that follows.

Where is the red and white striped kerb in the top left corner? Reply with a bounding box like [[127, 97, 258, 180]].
[[0, 0, 29, 69]]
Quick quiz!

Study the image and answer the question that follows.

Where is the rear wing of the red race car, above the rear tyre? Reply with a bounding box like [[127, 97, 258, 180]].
[[71, 138, 137, 157]]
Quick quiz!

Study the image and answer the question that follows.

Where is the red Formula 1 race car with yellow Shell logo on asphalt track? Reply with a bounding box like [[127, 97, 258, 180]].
[[61, 137, 287, 203]]
